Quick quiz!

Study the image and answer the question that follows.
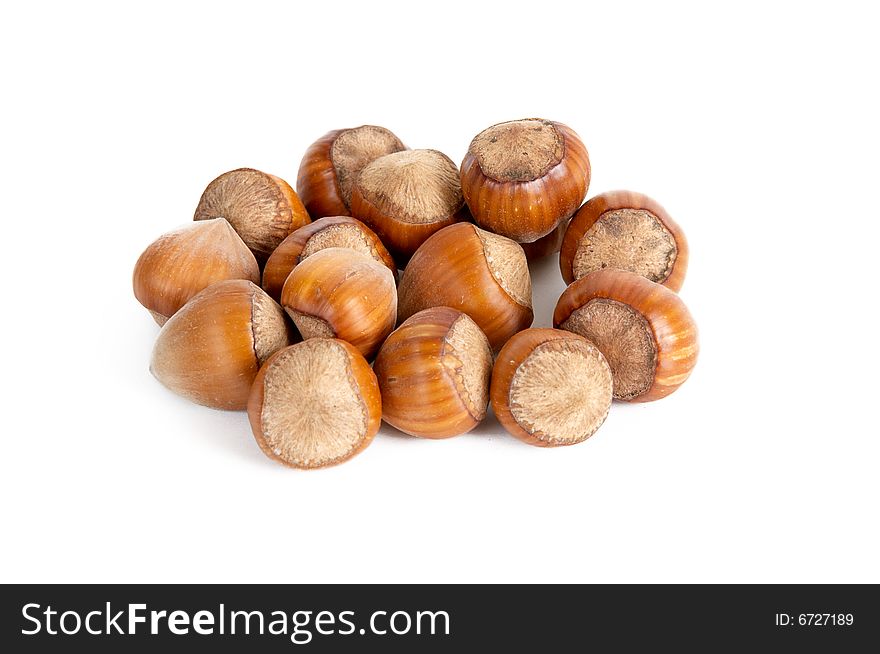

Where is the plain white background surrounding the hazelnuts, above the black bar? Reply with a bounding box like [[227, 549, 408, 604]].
[[0, 1, 880, 582]]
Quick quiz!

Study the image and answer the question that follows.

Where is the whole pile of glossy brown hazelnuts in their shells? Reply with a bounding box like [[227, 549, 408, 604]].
[[134, 119, 698, 468]]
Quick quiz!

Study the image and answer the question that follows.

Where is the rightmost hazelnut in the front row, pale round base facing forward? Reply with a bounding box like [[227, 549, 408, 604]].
[[490, 328, 612, 447]]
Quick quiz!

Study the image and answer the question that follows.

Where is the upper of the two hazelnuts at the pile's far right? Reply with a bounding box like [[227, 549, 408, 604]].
[[559, 191, 688, 291]]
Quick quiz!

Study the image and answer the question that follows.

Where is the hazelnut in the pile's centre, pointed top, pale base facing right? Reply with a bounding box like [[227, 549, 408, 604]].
[[398, 223, 534, 351]]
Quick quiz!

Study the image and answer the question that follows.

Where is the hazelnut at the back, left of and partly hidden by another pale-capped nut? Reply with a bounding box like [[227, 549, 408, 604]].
[[296, 125, 406, 218]]
